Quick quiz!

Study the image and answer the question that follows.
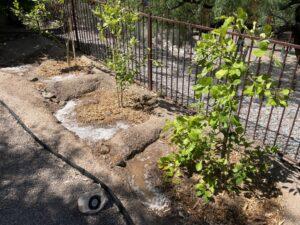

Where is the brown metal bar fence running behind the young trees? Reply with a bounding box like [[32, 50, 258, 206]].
[[48, 0, 300, 162]]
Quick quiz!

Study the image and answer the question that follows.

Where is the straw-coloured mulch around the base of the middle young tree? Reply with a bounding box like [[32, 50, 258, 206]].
[[76, 90, 150, 125]]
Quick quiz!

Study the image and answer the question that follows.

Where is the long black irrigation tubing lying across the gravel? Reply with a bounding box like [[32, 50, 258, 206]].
[[0, 99, 134, 225]]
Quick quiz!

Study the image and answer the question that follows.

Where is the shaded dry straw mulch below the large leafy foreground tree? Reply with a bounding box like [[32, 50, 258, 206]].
[[166, 178, 283, 225]]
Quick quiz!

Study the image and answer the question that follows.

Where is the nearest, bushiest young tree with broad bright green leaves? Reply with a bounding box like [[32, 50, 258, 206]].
[[159, 9, 290, 201]]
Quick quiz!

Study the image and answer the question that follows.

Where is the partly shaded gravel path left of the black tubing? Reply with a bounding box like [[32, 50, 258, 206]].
[[0, 106, 123, 225]]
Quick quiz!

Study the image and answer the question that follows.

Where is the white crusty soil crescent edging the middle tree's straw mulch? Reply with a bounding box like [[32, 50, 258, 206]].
[[55, 100, 129, 142]]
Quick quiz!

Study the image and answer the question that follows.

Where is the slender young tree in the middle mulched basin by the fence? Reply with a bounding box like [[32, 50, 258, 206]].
[[94, 0, 138, 107]]
